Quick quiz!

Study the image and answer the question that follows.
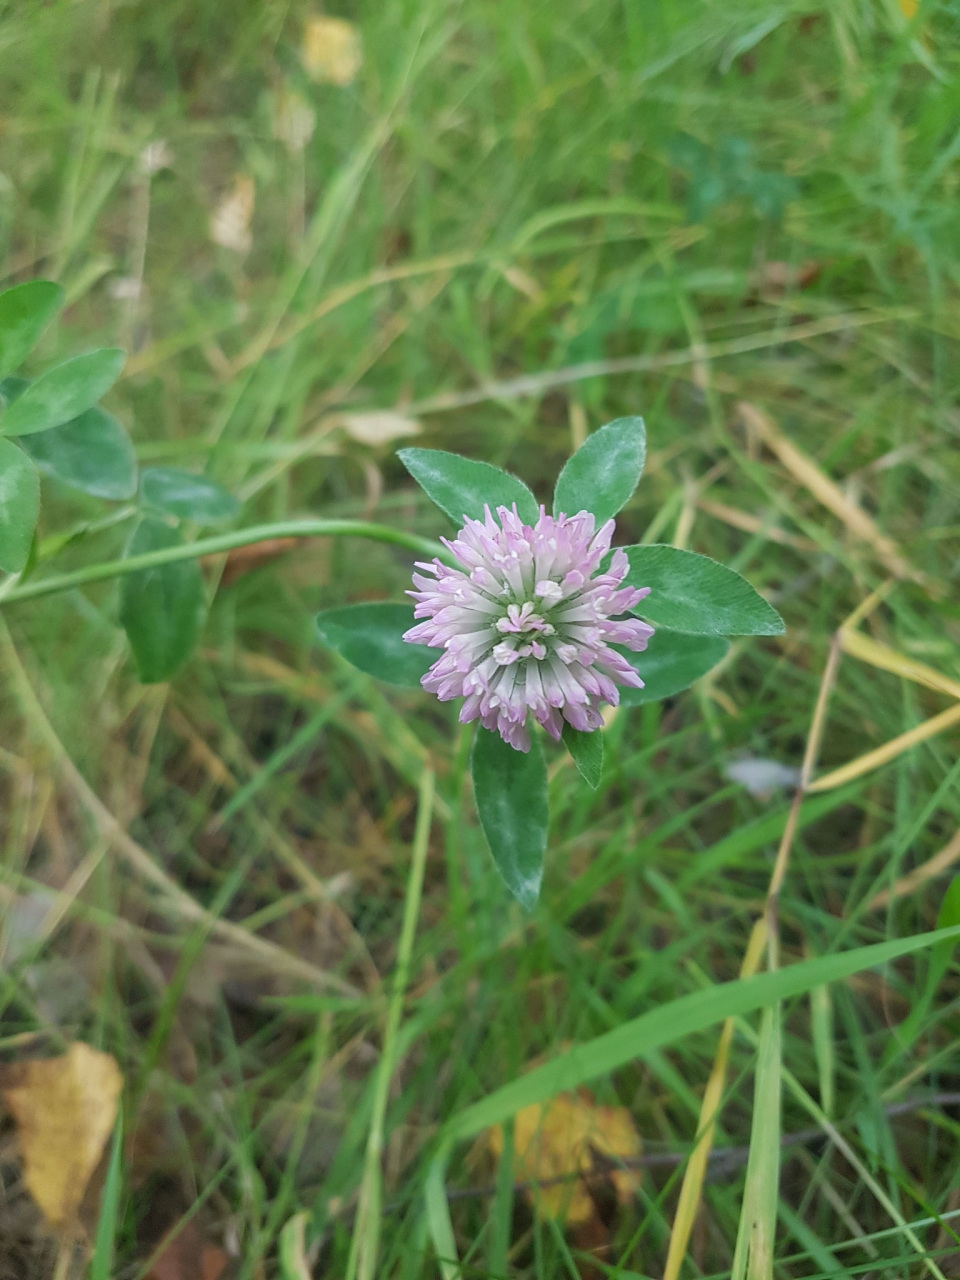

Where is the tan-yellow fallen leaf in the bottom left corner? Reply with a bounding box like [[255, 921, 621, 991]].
[[3, 1043, 123, 1228]]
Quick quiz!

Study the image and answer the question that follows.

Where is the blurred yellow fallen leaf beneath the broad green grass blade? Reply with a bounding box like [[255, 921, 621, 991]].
[[486, 1089, 641, 1226]]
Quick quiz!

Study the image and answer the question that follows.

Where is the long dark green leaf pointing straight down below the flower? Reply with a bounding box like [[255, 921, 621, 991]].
[[472, 728, 547, 911]]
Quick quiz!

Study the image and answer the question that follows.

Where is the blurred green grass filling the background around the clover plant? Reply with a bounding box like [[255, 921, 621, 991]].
[[0, 0, 960, 1280]]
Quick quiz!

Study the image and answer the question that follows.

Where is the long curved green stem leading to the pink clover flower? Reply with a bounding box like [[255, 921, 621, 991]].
[[0, 520, 447, 604]]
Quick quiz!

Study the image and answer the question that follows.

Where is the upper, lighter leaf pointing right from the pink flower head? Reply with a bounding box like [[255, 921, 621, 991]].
[[623, 545, 786, 636]]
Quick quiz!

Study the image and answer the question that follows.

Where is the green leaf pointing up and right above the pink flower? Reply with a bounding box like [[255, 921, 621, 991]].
[[553, 417, 646, 526]]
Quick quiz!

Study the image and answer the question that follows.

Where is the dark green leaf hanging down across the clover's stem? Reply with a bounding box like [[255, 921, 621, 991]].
[[120, 518, 206, 685]]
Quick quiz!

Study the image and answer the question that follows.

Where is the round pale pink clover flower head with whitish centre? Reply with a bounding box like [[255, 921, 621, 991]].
[[403, 504, 653, 751]]
